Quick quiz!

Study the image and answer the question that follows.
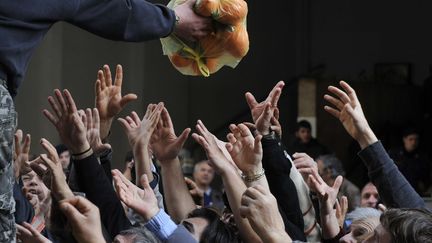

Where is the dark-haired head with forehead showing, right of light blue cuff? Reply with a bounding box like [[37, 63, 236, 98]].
[[182, 208, 240, 243]]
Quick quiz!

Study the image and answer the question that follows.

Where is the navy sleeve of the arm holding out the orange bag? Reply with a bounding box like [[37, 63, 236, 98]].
[[66, 0, 175, 41]]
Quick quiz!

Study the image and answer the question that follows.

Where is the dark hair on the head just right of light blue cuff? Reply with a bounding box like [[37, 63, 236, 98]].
[[188, 207, 241, 243]]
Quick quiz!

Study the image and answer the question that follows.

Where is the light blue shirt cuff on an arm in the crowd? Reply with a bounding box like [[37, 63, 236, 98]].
[[145, 209, 177, 241]]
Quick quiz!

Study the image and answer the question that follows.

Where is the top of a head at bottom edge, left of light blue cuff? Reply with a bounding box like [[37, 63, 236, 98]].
[[113, 227, 161, 243]]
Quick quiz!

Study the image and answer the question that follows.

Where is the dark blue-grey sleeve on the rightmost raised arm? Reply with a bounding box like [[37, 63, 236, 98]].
[[358, 141, 426, 208]]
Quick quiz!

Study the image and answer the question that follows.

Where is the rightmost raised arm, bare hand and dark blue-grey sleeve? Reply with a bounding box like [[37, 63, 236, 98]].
[[324, 81, 425, 208]]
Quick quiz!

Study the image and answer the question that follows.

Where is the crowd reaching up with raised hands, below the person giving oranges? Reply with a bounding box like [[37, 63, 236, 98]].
[[3, 65, 432, 243]]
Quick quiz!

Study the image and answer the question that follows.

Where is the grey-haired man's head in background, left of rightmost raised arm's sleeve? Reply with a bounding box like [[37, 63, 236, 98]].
[[316, 154, 345, 185]]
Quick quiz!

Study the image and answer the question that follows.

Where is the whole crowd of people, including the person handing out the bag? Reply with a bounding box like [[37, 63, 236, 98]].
[[0, 0, 432, 243]]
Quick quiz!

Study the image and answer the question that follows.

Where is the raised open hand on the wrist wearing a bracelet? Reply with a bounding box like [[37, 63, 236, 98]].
[[226, 124, 263, 176]]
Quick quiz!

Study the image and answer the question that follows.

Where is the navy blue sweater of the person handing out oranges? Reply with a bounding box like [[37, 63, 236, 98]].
[[0, 0, 175, 96]]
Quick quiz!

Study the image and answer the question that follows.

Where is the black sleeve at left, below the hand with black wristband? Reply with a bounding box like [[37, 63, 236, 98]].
[[73, 154, 131, 238]]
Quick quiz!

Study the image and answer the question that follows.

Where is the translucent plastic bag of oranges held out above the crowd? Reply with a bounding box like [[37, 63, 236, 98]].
[[161, 0, 249, 77]]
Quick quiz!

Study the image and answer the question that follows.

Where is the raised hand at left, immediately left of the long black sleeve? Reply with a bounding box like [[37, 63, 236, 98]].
[[31, 138, 73, 200]]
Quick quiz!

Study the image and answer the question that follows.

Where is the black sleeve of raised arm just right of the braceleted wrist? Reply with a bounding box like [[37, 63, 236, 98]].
[[262, 138, 306, 241]]
